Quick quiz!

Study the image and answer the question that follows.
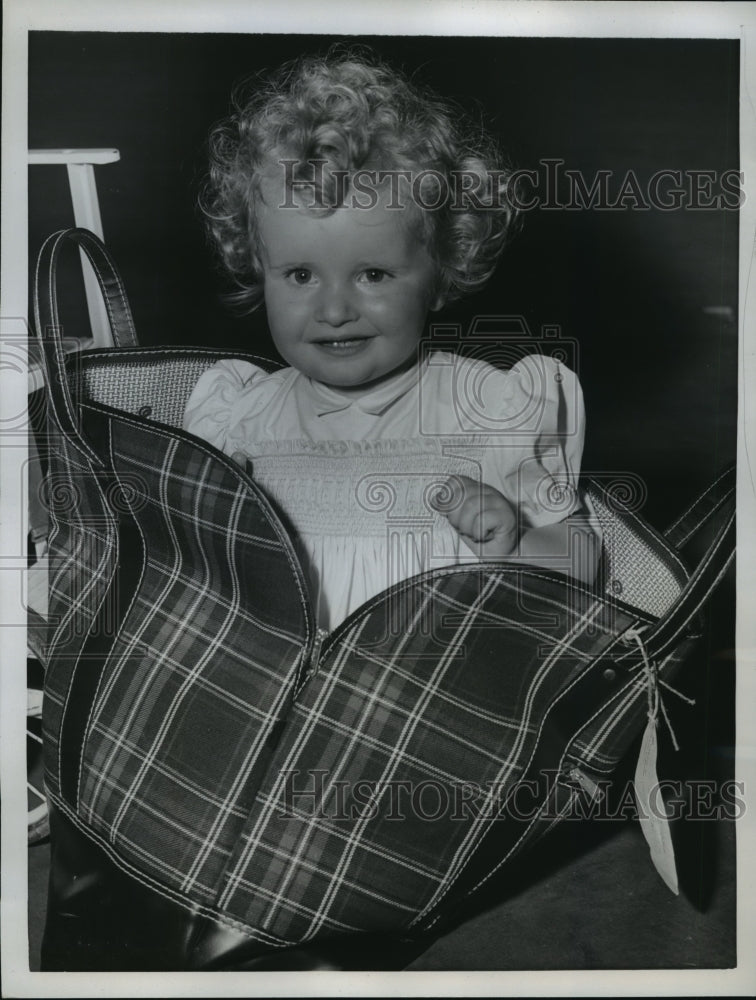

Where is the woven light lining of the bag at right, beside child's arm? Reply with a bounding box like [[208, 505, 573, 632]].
[[589, 490, 686, 618]]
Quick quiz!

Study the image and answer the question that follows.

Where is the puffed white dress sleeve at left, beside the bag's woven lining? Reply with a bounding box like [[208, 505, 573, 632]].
[[184, 358, 278, 454]]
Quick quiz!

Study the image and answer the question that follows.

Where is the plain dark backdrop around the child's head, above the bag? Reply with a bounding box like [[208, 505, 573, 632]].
[[29, 32, 739, 526]]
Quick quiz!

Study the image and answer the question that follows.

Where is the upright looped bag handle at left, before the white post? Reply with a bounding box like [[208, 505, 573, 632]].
[[34, 229, 138, 465]]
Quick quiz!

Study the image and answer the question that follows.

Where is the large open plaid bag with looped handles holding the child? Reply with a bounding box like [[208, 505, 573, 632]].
[[36, 230, 734, 969]]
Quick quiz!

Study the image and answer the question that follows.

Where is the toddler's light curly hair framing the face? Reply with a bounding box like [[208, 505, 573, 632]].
[[200, 48, 517, 311]]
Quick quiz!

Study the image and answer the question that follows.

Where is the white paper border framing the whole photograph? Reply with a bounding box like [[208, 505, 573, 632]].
[[0, 0, 756, 997]]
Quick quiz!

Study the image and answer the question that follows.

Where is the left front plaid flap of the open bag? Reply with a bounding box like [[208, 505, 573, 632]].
[[78, 410, 309, 902]]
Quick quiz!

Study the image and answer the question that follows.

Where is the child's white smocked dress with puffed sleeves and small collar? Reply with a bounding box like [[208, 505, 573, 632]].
[[184, 352, 584, 629]]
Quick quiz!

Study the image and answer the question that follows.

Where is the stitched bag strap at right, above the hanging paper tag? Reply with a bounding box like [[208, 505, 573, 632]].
[[643, 466, 736, 660]]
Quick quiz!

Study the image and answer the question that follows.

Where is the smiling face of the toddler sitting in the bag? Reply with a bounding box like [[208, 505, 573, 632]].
[[258, 184, 440, 389]]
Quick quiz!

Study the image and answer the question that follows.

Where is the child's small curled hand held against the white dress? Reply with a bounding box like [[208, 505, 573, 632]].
[[432, 476, 517, 558]]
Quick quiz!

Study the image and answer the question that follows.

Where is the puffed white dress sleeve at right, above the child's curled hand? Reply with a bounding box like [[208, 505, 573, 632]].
[[482, 355, 585, 528]]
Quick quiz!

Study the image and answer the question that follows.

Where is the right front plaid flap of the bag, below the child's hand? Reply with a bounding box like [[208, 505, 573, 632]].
[[219, 569, 636, 944]]
